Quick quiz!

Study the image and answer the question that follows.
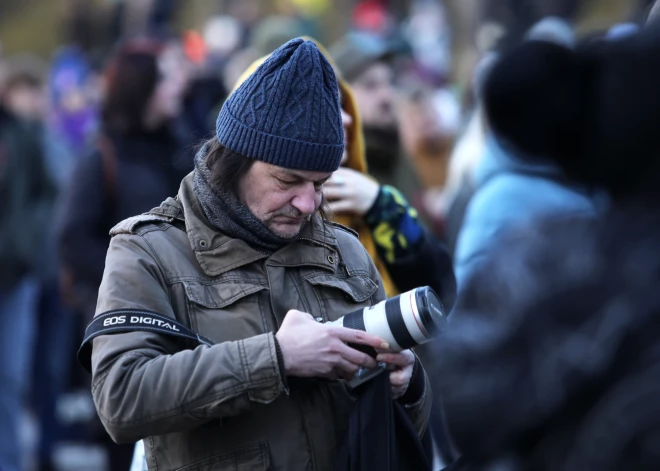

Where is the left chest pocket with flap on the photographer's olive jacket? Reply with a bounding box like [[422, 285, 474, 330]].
[[183, 281, 271, 343]]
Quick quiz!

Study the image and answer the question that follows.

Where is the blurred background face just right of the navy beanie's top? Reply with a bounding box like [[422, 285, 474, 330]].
[[351, 62, 397, 129]]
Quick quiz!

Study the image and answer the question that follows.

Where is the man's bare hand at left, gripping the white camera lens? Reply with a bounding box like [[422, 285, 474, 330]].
[[275, 310, 389, 379]]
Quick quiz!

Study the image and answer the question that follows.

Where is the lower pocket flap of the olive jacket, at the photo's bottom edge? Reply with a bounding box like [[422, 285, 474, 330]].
[[176, 442, 270, 471]]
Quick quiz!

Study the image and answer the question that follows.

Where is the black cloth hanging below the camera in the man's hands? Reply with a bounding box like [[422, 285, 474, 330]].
[[335, 373, 431, 471]]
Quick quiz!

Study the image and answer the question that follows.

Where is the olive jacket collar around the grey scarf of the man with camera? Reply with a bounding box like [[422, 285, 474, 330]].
[[156, 173, 339, 276]]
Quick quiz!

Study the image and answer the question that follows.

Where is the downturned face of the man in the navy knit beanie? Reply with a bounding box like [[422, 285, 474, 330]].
[[238, 161, 332, 239]]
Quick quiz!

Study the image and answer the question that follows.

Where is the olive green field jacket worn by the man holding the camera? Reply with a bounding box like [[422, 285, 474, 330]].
[[87, 174, 431, 471]]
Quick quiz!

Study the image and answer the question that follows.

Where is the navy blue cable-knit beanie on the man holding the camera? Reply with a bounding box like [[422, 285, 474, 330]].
[[216, 38, 344, 172]]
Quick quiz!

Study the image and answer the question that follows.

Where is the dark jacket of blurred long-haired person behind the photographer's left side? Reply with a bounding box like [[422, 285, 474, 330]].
[[58, 128, 193, 310]]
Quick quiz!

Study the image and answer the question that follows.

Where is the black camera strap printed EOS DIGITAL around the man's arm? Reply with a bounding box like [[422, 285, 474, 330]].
[[78, 309, 213, 373]]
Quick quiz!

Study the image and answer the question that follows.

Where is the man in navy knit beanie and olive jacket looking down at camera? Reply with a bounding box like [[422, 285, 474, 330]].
[[79, 39, 431, 471]]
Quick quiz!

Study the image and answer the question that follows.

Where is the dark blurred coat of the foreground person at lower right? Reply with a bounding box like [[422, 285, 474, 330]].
[[427, 210, 660, 471]]
